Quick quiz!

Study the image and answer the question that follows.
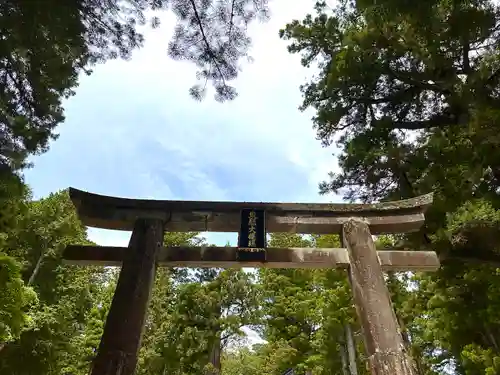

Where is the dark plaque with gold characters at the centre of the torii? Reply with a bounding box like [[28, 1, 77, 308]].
[[238, 208, 266, 262]]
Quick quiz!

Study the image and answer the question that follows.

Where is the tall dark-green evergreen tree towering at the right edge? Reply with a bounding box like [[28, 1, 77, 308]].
[[281, 0, 500, 374]]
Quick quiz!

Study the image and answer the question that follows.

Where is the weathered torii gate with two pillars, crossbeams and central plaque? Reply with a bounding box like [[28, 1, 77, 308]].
[[63, 188, 440, 375]]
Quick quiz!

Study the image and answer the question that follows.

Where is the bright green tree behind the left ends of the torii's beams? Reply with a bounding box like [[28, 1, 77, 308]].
[[0, 191, 103, 375]]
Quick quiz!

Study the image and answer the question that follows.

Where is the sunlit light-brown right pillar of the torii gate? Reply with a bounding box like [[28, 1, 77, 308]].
[[343, 219, 416, 375]]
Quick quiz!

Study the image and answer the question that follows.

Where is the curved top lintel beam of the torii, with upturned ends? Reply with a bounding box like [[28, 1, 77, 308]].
[[69, 188, 432, 234]]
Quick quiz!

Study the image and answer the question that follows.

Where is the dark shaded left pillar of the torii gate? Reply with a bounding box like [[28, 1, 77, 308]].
[[91, 219, 163, 375]]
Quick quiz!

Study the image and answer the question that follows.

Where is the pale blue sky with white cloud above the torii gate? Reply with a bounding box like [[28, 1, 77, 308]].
[[26, 0, 340, 250]]
